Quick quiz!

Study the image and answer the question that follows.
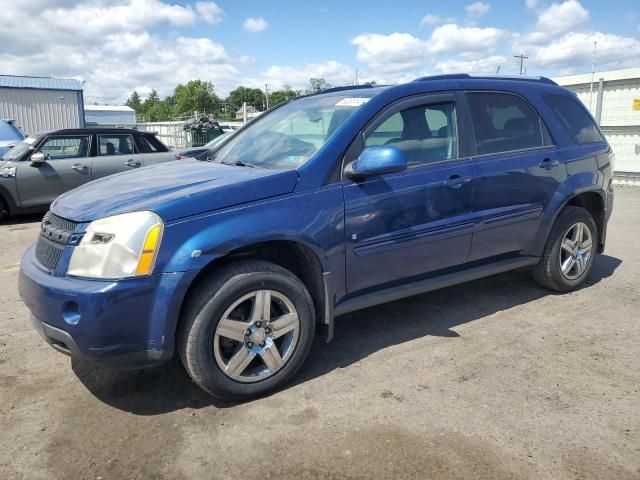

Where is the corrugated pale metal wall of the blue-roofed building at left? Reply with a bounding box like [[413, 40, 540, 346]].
[[0, 88, 83, 134]]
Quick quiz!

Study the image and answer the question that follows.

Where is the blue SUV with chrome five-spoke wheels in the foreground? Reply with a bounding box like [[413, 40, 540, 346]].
[[20, 75, 613, 400]]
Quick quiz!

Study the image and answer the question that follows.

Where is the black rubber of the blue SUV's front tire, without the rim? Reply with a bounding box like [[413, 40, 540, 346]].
[[177, 260, 315, 401]]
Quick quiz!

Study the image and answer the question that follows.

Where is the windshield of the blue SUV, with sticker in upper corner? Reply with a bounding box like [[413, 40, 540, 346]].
[[209, 92, 369, 170]]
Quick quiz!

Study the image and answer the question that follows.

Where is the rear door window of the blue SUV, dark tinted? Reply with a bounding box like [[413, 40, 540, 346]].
[[467, 93, 544, 155]]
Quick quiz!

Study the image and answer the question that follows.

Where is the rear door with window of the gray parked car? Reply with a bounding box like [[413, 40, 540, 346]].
[[92, 133, 144, 179]]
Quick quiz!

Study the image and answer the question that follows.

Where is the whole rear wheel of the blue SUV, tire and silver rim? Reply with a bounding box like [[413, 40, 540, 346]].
[[533, 206, 598, 292]]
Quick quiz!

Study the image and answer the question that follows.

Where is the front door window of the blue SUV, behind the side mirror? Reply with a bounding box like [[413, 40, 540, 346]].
[[364, 102, 458, 166]]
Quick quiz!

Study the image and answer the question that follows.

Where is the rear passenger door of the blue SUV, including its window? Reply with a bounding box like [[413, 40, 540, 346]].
[[466, 92, 567, 261]]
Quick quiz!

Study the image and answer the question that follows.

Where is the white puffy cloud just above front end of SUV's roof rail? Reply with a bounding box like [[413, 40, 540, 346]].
[[429, 23, 505, 53]]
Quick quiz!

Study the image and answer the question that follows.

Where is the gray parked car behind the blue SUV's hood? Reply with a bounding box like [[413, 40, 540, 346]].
[[0, 127, 176, 218]]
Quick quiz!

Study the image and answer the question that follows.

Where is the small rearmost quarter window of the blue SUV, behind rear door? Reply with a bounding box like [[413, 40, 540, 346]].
[[542, 94, 604, 145]]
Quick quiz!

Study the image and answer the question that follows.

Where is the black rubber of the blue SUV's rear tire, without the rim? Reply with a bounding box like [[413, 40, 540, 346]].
[[533, 206, 598, 292]]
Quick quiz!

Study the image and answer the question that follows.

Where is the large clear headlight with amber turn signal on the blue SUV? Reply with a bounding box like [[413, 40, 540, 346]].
[[67, 212, 163, 279]]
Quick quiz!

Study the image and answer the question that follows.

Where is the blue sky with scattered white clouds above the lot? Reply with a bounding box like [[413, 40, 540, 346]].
[[0, 0, 640, 104]]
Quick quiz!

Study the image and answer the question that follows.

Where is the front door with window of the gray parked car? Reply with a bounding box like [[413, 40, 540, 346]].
[[16, 135, 91, 207]]
